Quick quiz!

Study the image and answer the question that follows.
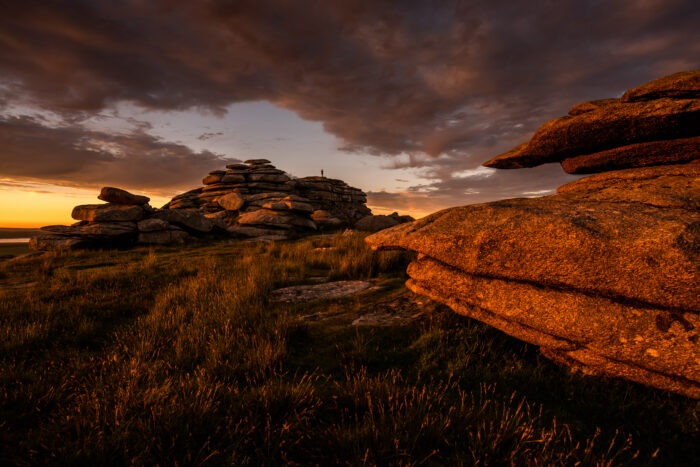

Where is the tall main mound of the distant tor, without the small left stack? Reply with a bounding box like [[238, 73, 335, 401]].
[[164, 159, 372, 237]]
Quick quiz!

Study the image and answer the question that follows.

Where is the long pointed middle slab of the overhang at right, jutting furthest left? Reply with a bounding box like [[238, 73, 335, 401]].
[[484, 99, 700, 169]]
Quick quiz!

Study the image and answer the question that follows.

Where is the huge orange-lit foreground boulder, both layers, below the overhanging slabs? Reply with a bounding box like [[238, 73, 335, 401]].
[[367, 163, 700, 398]]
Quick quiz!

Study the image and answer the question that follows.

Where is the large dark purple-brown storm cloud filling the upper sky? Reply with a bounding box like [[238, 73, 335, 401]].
[[0, 0, 700, 203]]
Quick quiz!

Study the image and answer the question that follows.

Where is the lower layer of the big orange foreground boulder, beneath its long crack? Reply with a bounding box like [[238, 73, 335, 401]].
[[407, 257, 700, 398]]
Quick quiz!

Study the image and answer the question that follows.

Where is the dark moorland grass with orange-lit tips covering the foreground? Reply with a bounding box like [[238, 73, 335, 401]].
[[0, 234, 700, 465]]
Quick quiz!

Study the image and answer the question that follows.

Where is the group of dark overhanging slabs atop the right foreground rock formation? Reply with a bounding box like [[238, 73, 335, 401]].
[[484, 70, 700, 173]]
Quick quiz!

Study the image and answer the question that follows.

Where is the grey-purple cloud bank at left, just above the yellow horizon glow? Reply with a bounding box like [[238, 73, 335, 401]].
[[0, 117, 230, 194]]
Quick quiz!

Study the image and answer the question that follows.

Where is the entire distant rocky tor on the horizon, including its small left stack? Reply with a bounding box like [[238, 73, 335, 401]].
[[30, 159, 413, 250]]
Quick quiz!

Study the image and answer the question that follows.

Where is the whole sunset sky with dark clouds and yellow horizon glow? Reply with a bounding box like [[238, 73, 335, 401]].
[[0, 0, 700, 227]]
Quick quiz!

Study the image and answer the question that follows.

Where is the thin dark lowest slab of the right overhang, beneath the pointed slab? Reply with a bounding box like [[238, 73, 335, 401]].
[[561, 137, 700, 174]]
